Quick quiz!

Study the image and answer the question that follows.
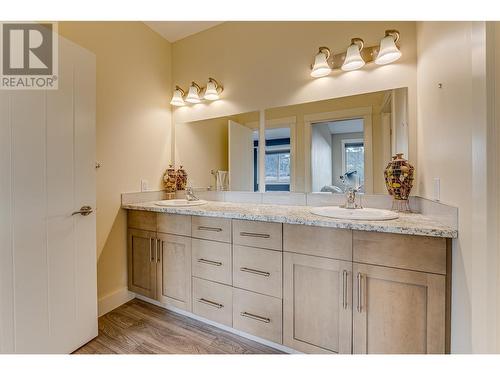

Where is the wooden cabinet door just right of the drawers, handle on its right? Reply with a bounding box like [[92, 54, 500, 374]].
[[283, 252, 352, 353]]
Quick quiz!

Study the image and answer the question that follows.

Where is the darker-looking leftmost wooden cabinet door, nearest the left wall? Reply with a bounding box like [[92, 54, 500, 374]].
[[127, 228, 156, 298]]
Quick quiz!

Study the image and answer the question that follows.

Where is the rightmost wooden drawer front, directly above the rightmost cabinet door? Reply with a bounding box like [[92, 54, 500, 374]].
[[353, 231, 446, 275]]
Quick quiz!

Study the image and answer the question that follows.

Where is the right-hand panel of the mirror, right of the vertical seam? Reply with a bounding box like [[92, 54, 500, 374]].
[[265, 88, 409, 194]]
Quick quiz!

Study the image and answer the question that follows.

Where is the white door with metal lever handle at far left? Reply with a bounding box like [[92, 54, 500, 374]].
[[0, 38, 97, 353]]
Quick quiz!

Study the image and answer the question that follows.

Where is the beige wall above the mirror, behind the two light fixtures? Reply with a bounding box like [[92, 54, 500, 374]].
[[172, 22, 416, 176]]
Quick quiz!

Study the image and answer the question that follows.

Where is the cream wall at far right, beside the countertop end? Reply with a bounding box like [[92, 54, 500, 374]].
[[417, 22, 498, 353]]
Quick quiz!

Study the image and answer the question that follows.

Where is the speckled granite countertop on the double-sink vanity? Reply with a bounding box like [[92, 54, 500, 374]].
[[122, 201, 458, 238]]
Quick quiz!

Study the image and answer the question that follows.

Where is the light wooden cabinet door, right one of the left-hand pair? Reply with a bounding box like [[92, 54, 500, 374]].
[[157, 233, 192, 311]]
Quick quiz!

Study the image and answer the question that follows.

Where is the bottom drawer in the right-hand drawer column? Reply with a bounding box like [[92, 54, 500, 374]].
[[233, 288, 283, 344]]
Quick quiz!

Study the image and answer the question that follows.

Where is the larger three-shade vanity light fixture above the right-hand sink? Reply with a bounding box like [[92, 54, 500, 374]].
[[311, 30, 402, 78]]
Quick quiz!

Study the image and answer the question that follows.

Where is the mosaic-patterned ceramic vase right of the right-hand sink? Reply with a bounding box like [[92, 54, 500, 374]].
[[384, 154, 415, 211]]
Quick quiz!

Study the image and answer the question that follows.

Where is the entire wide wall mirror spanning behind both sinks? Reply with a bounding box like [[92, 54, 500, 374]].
[[175, 88, 409, 194]]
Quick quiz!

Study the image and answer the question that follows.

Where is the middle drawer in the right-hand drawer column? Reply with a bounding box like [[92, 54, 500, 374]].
[[233, 245, 282, 298]]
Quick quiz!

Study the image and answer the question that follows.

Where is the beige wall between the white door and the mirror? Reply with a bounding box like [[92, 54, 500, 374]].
[[59, 22, 172, 310]]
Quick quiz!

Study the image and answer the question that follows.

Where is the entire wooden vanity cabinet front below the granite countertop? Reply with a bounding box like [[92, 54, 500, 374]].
[[128, 211, 451, 354]]
